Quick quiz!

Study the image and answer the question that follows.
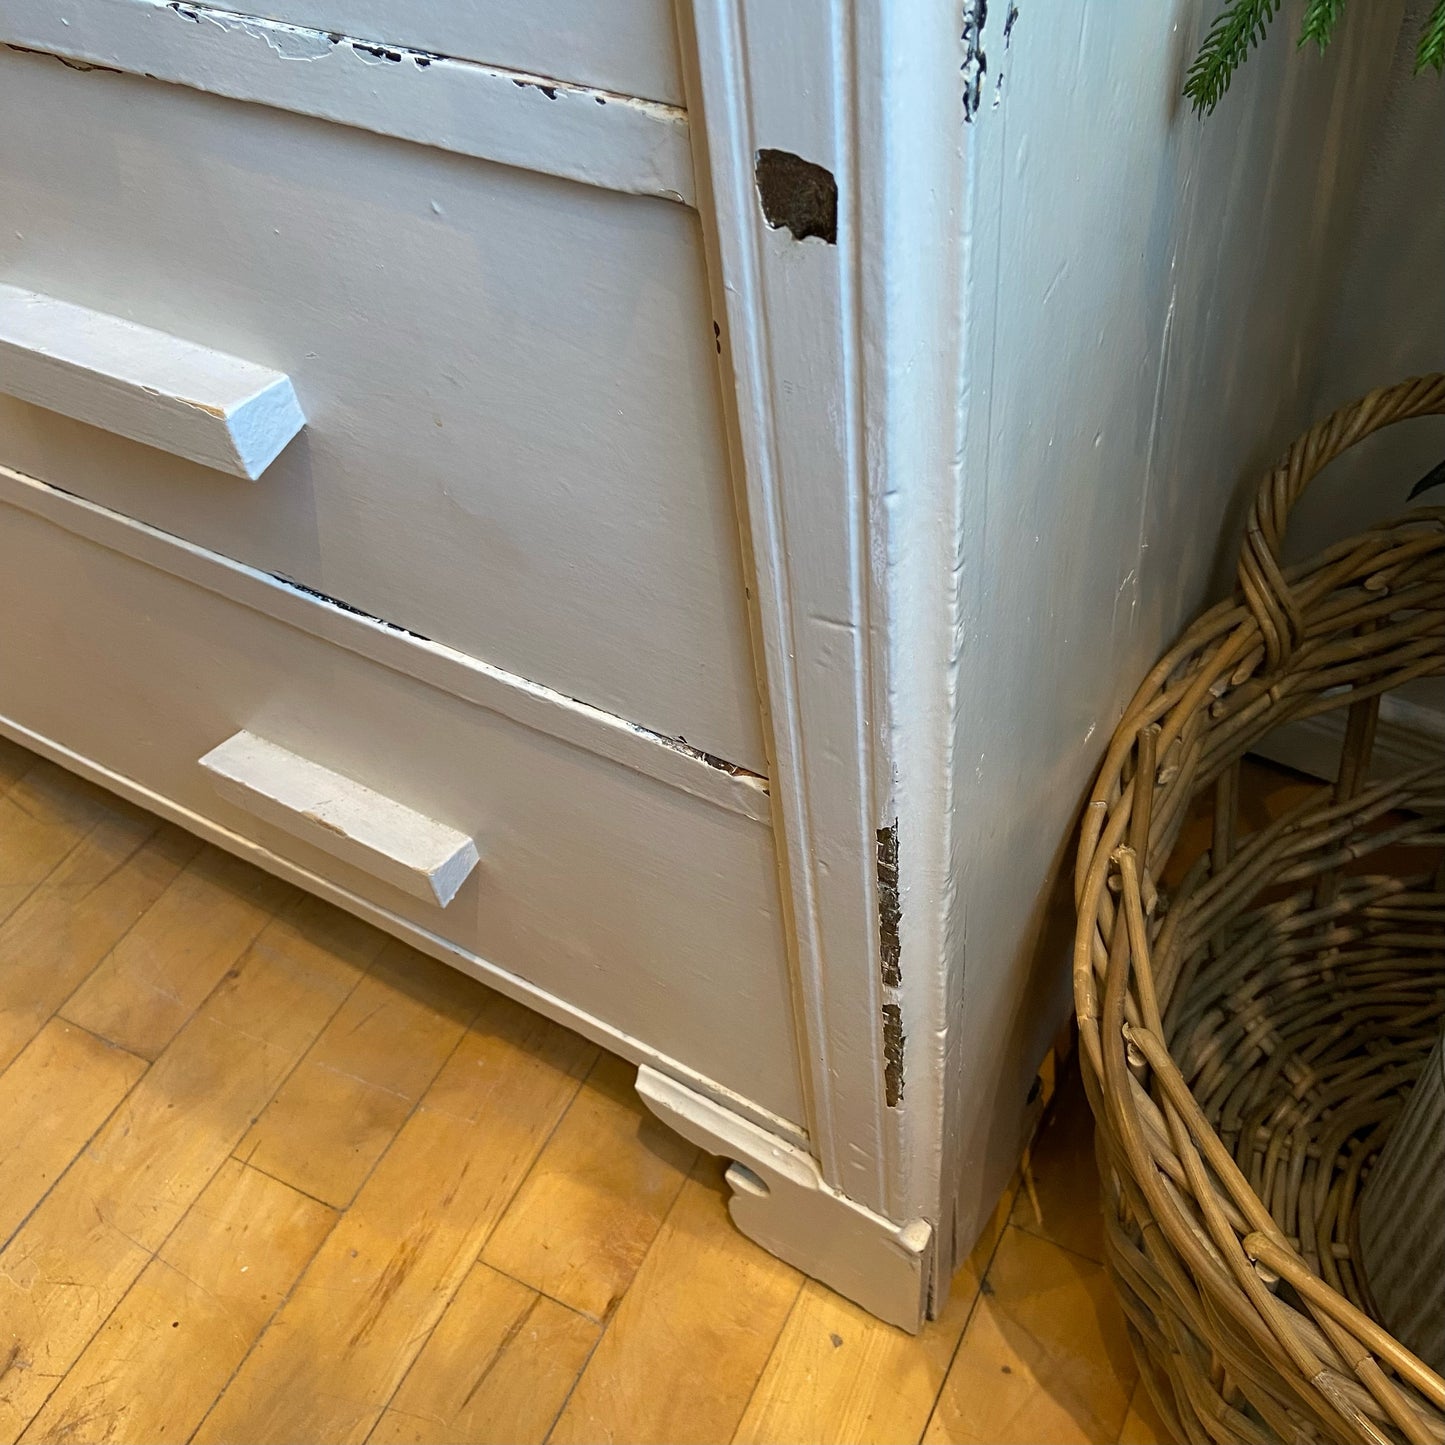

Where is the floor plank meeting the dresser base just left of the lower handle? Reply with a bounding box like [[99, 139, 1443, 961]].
[[61, 848, 301, 1059]]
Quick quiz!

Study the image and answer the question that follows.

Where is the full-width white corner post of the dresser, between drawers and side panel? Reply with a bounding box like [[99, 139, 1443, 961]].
[[679, 0, 967, 1260]]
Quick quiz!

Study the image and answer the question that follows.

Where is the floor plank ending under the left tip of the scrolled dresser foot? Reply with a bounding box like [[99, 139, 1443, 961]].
[[483, 1053, 698, 1319]]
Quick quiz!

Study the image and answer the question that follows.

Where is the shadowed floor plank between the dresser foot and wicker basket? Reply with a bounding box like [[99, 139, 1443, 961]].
[[923, 1224, 1136, 1445]]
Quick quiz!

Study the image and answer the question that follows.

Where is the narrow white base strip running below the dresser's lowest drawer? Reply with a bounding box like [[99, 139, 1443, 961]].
[[0, 714, 808, 1157]]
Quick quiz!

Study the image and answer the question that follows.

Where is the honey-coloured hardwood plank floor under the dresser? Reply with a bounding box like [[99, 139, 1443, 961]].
[[0, 743, 1165, 1445]]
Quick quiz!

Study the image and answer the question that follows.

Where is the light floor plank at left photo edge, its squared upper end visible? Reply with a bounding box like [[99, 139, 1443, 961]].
[[0, 1019, 146, 1243]]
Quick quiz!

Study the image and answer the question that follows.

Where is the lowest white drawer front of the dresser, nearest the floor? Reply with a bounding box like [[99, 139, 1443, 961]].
[[0, 475, 803, 1120]]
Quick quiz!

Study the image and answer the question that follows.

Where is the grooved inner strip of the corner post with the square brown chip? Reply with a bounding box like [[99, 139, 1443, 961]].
[[682, 0, 892, 1212]]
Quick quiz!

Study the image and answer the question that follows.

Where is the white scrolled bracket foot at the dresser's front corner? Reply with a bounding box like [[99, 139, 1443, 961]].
[[637, 1064, 933, 1334]]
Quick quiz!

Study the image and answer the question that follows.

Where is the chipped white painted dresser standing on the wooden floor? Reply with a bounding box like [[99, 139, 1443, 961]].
[[0, 0, 1398, 1328]]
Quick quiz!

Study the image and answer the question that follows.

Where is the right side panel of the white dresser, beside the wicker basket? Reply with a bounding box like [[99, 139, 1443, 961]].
[[948, 0, 1398, 1265]]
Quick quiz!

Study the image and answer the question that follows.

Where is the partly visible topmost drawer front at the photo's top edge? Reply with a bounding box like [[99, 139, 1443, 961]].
[[184, 0, 682, 105]]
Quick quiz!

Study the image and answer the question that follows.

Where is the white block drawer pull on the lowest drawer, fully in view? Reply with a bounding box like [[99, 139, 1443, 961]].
[[201, 733, 477, 907]]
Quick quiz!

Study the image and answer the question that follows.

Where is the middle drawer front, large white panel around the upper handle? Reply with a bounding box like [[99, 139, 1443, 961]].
[[0, 45, 764, 772]]
